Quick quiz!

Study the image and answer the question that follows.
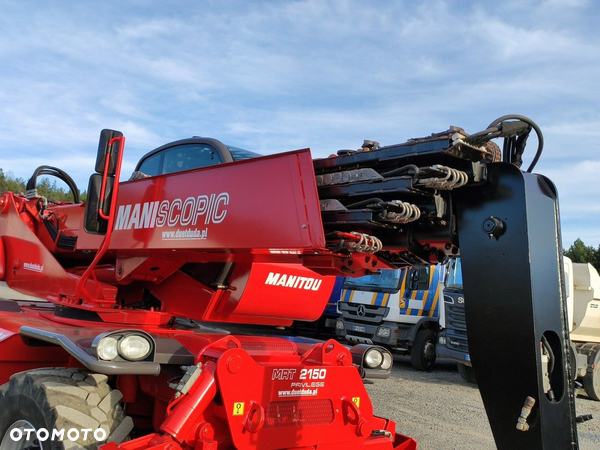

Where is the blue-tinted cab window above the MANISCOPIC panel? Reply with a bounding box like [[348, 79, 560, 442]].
[[138, 144, 223, 176]]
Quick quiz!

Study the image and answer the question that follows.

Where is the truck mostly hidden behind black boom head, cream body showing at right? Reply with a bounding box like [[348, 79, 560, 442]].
[[436, 256, 600, 401]]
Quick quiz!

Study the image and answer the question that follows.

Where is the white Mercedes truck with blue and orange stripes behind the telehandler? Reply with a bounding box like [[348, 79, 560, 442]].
[[336, 265, 444, 371]]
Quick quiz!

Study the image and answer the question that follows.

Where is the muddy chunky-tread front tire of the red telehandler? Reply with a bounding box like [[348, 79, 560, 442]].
[[0, 368, 133, 450]]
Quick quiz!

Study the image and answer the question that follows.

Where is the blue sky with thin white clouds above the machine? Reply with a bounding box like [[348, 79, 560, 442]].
[[0, 0, 600, 247]]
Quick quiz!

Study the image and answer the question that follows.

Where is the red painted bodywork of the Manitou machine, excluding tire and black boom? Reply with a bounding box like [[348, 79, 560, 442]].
[[0, 134, 416, 450]]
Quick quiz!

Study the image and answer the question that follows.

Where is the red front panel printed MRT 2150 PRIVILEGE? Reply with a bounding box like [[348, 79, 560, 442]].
[[217, 345, 376, 450]]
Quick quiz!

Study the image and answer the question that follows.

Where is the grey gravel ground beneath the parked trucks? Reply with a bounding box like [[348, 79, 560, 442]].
[[367, 356, 600, 450]]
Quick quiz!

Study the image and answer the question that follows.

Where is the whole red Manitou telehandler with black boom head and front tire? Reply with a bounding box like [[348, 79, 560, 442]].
[[0, 116, 578, 450]]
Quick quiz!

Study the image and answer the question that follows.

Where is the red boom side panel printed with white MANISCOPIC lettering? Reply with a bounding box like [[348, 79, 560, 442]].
[[100, 150, 325, 254]]
